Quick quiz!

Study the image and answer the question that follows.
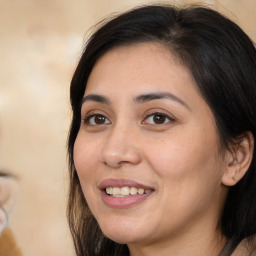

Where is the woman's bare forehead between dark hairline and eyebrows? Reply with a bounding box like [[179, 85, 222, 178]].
[[86, 43, 197, 96]]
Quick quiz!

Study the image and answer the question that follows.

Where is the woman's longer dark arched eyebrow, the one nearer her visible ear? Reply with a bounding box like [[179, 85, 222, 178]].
[[134, 92, 190, 110]]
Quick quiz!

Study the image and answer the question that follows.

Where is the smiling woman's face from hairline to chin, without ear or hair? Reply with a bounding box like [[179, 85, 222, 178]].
[[74, 43, 226, 244]]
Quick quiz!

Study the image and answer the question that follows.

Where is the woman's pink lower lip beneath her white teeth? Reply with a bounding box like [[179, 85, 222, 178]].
[[101, 191, 153, 208]]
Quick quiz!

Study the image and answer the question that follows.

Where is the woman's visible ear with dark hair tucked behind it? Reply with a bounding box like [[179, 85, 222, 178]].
[[222, 131, 254, 186]]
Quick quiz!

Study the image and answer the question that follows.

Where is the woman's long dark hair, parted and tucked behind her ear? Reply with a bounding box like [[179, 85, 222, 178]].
[[68, 5, 256, 256]]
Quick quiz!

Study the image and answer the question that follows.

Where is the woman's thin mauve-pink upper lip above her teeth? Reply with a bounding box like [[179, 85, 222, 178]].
[[98, 178, 154, 190]]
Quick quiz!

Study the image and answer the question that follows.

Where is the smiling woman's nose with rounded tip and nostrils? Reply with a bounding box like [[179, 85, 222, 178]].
[[101, 126, 141, 168]]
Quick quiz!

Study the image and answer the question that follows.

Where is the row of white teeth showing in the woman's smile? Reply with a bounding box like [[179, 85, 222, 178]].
[[106, 187, 151, 197]]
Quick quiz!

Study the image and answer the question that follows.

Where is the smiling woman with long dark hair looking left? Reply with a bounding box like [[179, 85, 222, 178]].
[[68, 6, 256, 256]]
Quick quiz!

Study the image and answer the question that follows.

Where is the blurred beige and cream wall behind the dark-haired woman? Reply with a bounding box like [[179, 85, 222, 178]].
[[0, 0, 256, 256]]
